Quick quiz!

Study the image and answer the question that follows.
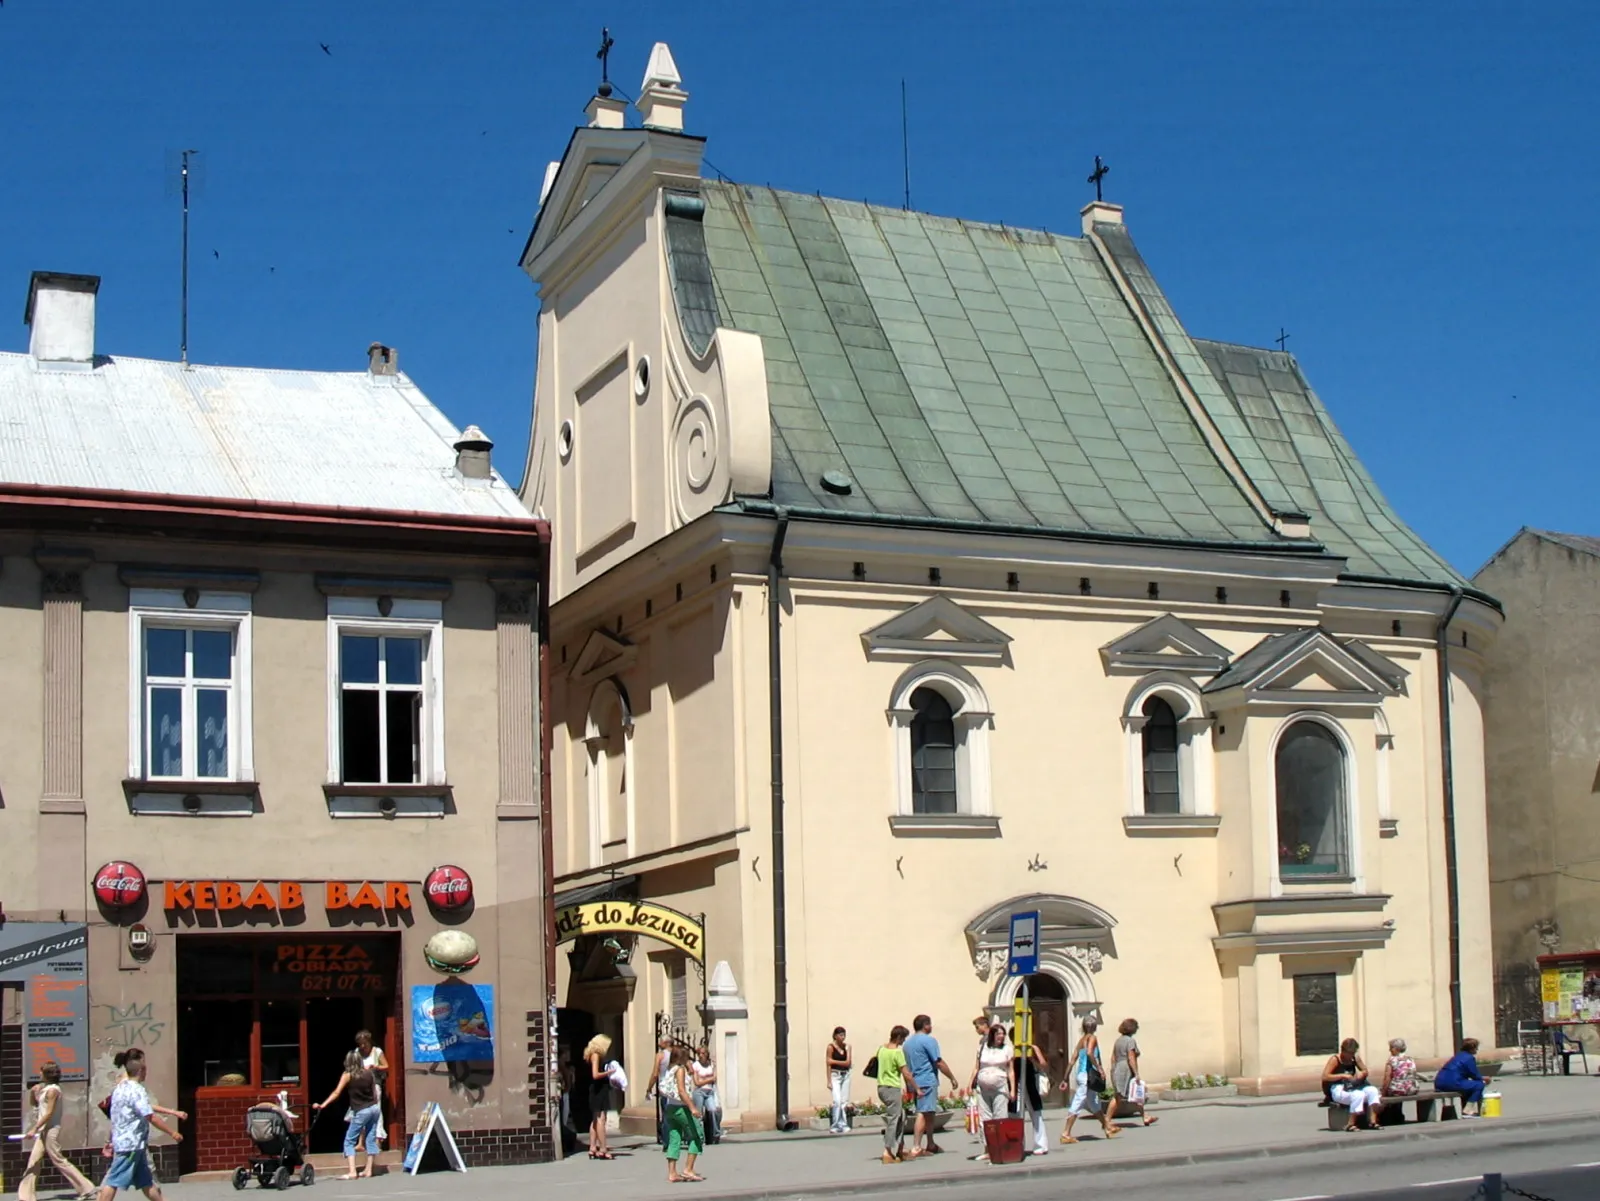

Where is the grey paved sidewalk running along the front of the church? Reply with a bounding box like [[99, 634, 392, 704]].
[[165, 1076, 1600, 1201]]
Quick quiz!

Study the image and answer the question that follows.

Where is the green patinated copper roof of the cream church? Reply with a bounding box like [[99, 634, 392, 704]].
[[667, 181, 1456, 582]]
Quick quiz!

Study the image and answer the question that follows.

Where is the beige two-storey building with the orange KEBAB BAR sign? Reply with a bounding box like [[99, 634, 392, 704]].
[[0, 273, 554, 1180]]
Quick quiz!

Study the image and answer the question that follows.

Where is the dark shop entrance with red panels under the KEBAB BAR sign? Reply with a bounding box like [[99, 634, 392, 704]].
[[178, 932, 405, 1172]]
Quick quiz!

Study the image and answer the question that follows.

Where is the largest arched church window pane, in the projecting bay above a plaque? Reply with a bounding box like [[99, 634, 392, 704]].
[[1275, 721, 1350, 880]]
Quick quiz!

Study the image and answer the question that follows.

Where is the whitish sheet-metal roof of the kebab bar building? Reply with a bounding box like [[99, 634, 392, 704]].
[[0, 353, 528, 517]]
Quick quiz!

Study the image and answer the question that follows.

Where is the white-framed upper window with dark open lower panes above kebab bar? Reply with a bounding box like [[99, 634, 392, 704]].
[[328, 597, 445, 787]]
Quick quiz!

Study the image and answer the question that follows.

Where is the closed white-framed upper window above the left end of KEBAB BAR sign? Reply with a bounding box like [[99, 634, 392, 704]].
[[128, 589, 253, 782]]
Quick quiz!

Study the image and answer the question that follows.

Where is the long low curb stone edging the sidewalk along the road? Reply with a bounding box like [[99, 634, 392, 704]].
[[665, 1113, 1600, 1201]]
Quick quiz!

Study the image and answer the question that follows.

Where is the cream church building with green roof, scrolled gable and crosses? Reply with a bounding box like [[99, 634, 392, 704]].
[[523, 46, 1499, 1124]]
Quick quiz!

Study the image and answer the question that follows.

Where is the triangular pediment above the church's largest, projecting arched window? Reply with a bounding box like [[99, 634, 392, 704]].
[[1205, 628, 1406, 705]]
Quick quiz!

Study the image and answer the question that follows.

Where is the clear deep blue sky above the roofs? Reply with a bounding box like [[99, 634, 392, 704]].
[[0, 0, 1600, 573]]
